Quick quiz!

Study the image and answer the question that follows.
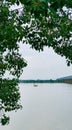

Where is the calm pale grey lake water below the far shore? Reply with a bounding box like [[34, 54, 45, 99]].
[[0, 84, 72, 130]]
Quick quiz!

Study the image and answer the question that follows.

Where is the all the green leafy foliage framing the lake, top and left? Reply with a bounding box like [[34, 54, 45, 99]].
[[0, 0, 72, 125]]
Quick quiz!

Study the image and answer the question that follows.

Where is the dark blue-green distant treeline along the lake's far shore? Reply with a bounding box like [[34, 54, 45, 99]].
[[19, 79, 64, 83]]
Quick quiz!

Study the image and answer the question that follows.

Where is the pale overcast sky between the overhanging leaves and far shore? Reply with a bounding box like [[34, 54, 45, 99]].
[[20, 43, 72, 79]]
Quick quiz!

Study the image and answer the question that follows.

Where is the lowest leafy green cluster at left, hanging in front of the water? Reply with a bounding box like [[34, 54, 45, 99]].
[[0, 79, 22, 125]]
